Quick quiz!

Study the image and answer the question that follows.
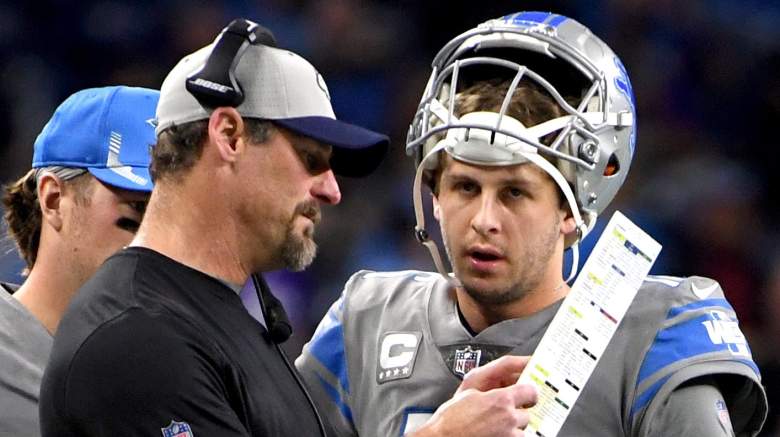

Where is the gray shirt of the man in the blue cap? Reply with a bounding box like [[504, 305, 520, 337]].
[[0, 284, 53, 437]]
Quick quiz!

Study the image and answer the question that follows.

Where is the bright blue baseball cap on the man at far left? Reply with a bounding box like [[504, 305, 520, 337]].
[[32, 86, 160, 191]]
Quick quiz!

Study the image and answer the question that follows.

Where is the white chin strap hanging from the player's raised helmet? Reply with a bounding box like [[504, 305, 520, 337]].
[[412, 113, 596, 287]]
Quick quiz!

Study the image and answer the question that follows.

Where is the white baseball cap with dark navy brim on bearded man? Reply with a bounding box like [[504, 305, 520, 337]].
[[157, 40, 389, 177]]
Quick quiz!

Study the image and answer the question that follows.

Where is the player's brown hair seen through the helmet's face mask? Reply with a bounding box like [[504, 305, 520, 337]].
[[423, 79, 565, 197]]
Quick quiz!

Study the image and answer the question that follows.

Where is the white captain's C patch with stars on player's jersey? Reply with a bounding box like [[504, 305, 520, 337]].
[[377, 332, 422, 384]]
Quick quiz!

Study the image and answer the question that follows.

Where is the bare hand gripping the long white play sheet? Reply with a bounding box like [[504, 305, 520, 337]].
[[409, 356, 537, 437]]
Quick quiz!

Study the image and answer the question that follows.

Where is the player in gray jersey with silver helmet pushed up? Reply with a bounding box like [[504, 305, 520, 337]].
[[296, 12, 767, 437]]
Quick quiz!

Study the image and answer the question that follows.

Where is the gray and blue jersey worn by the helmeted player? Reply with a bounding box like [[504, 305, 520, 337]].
[[296, 271, 767, 437]]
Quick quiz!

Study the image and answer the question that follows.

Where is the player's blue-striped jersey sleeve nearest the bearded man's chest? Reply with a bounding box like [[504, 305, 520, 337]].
[[295, 291, 357, 436]]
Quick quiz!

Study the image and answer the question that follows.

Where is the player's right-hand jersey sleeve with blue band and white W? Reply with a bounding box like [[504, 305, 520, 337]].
[[629, 277, 768, 436]]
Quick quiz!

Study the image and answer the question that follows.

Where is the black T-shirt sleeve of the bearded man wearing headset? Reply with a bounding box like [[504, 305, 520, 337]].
[[41, 310, 249, 437]]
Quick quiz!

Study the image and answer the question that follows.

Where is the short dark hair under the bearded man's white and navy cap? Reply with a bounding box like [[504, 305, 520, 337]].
[[149, 118, 275, 181]]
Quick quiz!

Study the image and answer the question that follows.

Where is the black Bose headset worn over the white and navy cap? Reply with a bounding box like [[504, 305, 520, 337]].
[[185, 18, 276, 108]]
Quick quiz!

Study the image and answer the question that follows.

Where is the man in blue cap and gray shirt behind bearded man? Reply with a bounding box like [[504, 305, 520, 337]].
[[0, 86, 159, 437]]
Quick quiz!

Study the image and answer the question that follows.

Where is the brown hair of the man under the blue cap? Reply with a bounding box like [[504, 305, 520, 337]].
[[3, 169, 95, 275]]
